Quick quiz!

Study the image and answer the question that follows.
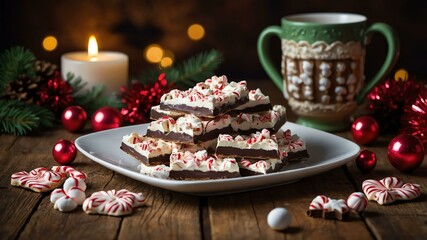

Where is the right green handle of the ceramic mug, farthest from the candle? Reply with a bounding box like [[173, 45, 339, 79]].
[[356, 23, 400, 104]]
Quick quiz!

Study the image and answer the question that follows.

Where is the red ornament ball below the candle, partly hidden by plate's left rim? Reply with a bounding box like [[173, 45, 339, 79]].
[[92, 107, 123, 132]]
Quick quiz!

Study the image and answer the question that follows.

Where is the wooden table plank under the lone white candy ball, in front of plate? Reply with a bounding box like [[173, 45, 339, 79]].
[[208, 169, 371, 239]]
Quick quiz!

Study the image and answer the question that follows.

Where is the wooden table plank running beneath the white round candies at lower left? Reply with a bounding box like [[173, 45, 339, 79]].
[[20, 150, 118, 239]]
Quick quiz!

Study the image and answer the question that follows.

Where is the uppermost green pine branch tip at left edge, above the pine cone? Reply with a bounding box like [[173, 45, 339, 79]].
[[0, 46, 36, 96]]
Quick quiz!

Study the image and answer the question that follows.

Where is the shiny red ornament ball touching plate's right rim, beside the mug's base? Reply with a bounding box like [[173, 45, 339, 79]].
[[351, 116, 380, 145]]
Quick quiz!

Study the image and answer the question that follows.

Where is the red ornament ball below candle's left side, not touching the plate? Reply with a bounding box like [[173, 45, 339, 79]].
[[61, 106, 87, 132]]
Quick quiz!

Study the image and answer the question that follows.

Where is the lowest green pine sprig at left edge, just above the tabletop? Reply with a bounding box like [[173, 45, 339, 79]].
[[0, 100, 55, 135]]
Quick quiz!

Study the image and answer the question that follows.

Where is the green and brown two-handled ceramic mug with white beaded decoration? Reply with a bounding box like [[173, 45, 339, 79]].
[[257, 13, 399, 131]]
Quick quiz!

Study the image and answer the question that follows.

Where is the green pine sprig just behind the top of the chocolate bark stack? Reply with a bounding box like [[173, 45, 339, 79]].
[[137, 49, 223, 88]]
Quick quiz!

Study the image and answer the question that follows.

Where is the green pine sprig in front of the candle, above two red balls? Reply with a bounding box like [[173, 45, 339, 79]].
[[65, 73, 122, 116]]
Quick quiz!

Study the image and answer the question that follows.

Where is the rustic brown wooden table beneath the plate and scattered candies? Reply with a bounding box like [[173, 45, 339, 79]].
[[0, 80, 427, 239]]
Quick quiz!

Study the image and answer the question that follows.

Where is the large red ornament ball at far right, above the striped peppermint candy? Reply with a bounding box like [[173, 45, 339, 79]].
[[387, 134, 424, 171]]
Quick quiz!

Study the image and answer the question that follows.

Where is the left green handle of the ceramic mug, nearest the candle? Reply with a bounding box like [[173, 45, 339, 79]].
[[257, 26, 286, 97]]
